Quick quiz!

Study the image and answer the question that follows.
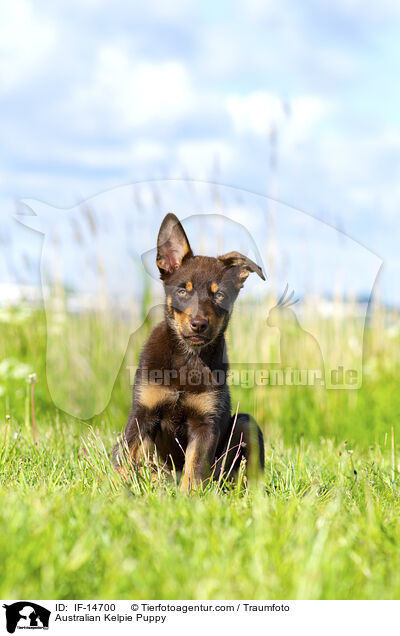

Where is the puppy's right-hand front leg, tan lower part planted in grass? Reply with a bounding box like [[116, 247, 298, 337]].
[[180, 421, 218, 493]]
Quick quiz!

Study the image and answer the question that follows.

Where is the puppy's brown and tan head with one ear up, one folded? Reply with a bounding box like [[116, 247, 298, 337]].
[[157, 214, 265, 349]]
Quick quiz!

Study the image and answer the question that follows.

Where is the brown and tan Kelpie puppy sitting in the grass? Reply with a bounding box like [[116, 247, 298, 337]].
[[113, 214, 265, 492]]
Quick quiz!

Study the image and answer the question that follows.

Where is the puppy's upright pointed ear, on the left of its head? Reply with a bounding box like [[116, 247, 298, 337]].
[[156, 214, 193, 278]]
